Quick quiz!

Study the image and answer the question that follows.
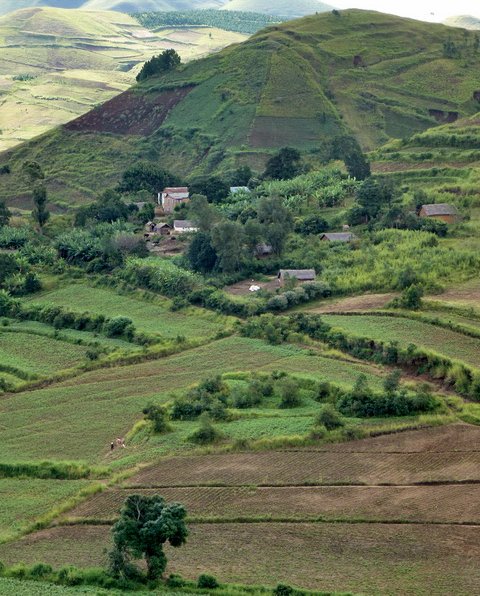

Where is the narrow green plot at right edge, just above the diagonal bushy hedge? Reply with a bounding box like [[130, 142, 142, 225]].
[[323, 315, 480, 366]]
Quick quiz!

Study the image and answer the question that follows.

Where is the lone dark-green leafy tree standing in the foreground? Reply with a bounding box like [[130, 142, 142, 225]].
[[110, 495, 188, 580]]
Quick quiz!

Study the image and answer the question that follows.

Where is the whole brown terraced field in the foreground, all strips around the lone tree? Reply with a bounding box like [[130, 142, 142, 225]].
[[0, 424, 480, 596]]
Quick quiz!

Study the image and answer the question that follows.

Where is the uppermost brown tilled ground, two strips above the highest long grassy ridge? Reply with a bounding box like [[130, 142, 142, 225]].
[[127, 424, 480, 488]]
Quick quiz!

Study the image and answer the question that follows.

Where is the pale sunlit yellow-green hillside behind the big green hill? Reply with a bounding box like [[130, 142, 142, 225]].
[[0, 8, 246, 150]]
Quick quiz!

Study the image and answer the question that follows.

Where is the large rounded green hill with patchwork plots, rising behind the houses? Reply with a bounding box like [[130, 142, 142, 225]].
[[0, 10, 480, 210]]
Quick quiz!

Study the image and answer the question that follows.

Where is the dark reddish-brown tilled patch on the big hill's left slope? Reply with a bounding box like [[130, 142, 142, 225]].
[[65, 87, 193, 135]]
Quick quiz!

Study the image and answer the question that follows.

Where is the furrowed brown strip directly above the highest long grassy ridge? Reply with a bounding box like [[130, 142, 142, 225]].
[[127, 448, 480, 488]]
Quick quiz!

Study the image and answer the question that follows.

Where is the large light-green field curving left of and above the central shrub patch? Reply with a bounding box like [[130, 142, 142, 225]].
[[0, 337, 381, 463]]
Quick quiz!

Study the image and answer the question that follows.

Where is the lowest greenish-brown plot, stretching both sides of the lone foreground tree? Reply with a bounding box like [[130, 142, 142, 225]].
[[0, 522, 480, 596]]
